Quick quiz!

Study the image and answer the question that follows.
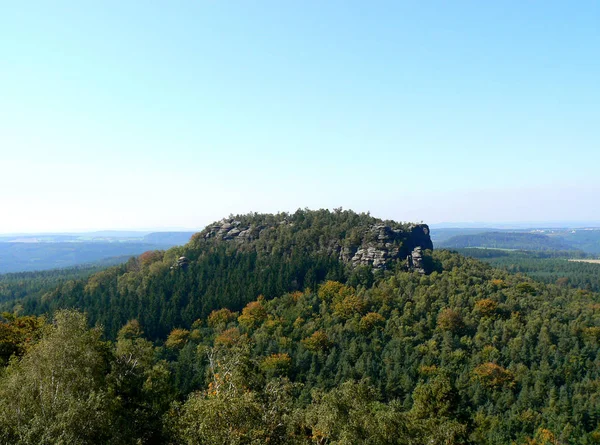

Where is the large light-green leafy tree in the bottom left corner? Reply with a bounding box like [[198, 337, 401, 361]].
[[0, 311, 122, 445]]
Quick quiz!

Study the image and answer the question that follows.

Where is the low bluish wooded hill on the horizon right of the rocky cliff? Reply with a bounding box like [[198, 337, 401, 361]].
[[440, 232, 577, 251]]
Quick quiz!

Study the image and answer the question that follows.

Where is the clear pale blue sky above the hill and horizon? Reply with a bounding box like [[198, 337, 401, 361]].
[[0, 0, 600, 232]]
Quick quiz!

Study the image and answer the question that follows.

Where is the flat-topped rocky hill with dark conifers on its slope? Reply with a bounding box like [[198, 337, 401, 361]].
[[23, 210, 433, 338]]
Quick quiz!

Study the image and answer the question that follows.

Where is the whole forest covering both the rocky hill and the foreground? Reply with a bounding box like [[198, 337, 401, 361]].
[[0, 211, 600, 445]]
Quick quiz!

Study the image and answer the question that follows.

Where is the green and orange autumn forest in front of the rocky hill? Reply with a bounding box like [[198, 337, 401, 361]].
[[0, 251, 600, 445]]
